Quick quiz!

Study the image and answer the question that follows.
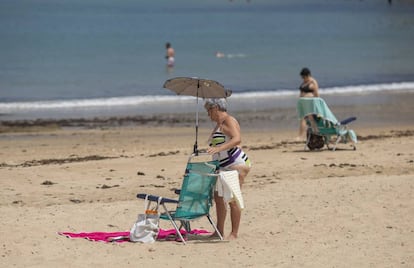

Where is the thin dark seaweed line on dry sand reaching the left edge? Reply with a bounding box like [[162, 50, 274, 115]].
[[0, 155, 126, 168]]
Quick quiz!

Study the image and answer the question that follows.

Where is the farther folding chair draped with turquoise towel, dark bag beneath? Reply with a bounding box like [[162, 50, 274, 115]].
[[297, 98, 357, 151]]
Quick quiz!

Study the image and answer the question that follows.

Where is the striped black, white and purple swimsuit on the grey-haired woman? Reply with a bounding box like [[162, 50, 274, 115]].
[[210, 128, 251, 169]]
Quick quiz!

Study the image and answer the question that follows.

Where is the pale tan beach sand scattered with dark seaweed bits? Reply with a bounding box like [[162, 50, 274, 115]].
[[0, 93, 414, 267]]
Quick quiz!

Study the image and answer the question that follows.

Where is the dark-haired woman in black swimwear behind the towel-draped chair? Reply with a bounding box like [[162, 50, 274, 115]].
[[296, 67, 319, 140]]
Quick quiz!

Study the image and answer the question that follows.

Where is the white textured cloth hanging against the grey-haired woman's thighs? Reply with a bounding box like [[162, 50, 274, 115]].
[[216, 170, 244, 209]]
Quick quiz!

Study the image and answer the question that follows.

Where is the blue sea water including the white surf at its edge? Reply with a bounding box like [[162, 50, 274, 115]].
[[0, 0, 414, 120]]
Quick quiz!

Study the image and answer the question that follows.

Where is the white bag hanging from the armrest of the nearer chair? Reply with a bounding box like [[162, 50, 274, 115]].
[[129, 195, 162, 243]]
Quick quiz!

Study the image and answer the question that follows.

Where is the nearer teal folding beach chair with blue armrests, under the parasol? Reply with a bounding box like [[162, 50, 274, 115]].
[[137, 157, 223, 244]]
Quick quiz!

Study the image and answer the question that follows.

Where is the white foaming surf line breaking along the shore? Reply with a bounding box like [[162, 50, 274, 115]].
[[0, 86, 414, 122]]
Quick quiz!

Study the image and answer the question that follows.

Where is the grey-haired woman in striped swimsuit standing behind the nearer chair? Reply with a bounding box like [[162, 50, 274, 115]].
[[204, 99, 251, 239]]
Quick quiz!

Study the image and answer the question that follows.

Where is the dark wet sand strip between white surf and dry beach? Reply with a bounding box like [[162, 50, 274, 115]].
[[0, 91, 414, 133]]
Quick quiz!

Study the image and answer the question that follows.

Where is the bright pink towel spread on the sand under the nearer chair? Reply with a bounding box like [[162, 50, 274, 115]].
[[58, 229, 210, 243]]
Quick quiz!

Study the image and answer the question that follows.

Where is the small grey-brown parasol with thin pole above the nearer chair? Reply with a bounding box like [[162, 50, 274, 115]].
[[163, 77, 232, 154]]
